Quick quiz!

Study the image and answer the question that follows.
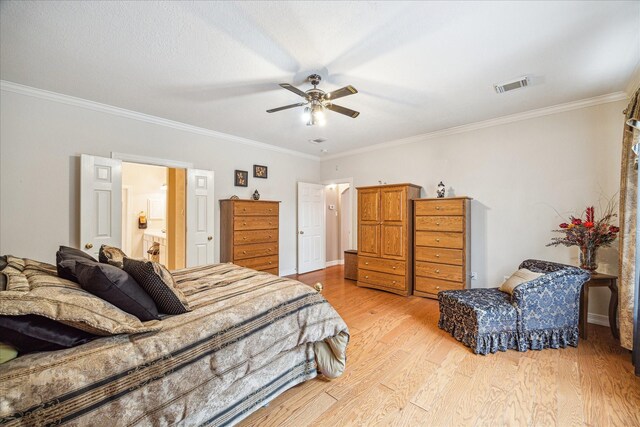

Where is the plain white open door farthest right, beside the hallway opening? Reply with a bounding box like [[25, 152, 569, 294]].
[[298, 182, 326, 274]]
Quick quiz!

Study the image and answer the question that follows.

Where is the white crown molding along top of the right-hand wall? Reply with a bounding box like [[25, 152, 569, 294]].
[[320, 92, 629, 162]]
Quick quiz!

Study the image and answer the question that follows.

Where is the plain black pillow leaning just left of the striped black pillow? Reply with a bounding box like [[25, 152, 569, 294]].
[[75, 260, 160, 321]]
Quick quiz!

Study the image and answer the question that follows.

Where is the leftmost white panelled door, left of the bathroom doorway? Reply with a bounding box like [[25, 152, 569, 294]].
[[80, 154, 122, 258]]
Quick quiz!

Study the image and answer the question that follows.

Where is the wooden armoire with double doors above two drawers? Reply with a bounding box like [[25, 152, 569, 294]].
[[357, 184, 421, 295]]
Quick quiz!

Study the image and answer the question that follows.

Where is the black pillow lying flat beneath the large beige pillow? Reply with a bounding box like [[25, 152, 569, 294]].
[[0, 314, 98, 354]]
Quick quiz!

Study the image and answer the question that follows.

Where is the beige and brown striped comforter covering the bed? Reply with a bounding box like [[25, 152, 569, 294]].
[[0, 264, 348, 426]]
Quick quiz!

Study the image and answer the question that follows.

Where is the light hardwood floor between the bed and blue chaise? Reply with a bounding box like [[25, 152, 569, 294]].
[[241, 266, 640, 427]]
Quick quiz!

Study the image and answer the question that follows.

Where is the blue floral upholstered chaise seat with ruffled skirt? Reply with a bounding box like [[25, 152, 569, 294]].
[[438, 259, 590, 354]]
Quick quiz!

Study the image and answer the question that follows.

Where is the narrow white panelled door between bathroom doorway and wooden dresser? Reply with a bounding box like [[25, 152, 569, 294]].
[[187, 169, 215, 267]]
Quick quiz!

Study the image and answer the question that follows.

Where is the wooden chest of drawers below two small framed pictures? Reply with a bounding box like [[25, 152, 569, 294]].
[[220, 199, 280, 275]]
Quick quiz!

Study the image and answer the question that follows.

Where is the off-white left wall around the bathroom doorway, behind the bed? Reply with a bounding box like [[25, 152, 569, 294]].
[[0, 90, 319, 274]]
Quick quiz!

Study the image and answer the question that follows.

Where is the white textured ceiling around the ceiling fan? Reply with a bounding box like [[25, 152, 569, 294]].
[[0, 1, 640, 155]]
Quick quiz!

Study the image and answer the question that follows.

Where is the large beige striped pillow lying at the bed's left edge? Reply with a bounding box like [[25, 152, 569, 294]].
[[0, 256, 161, 335]]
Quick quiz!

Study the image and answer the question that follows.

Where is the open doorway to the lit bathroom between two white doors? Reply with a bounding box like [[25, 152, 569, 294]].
[[122, 162, 186, 270]]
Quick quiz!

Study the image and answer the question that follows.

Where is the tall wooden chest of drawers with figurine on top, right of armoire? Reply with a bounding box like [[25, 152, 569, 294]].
[[413, 197, 471, 298]]
